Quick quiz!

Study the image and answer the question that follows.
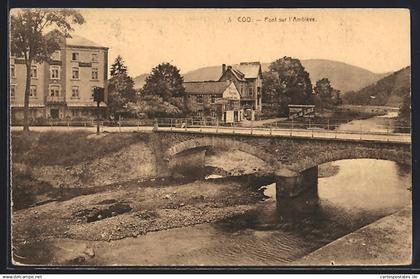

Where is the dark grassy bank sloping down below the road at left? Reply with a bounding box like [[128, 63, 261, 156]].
[[11, 131, 152, 209]]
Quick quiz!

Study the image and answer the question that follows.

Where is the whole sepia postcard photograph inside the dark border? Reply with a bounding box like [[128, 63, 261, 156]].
[[7, 8, 413, 268]]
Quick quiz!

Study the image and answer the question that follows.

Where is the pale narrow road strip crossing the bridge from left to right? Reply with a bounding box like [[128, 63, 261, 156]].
[[11, 126, 411, 143]]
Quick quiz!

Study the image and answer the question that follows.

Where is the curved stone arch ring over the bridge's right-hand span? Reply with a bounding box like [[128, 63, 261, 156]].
[[287, 148, 411, 173]]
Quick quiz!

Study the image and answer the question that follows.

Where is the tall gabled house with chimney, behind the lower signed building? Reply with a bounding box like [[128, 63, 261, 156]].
[[219, 62, 262, 120]]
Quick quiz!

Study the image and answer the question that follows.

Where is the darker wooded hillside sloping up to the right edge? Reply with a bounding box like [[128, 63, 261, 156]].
[[343, 66, 411, 107]]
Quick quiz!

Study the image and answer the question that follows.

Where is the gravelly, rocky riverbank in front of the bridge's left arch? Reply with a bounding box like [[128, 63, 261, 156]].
[[12, 178, 263, 264]]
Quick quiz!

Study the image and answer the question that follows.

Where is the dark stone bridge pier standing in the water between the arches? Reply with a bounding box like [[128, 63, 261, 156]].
[[276, 166, 319, 220]]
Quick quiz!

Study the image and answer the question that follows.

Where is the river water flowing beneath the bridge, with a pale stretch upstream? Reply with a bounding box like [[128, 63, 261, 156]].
[[88, 114, 411, 266]]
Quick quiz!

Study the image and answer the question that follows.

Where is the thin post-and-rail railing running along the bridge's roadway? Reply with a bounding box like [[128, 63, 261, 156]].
[[9, 118, 411, 142]]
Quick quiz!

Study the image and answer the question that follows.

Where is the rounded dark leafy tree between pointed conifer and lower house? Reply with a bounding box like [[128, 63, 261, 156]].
[[143, 63, 185, 102]]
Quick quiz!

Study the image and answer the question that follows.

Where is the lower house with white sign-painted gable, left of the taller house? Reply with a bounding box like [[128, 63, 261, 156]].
[[184, 80, 243, 123]]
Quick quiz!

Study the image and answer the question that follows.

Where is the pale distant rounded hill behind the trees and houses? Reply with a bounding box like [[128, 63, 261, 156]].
[[134, 59, 387, 92]]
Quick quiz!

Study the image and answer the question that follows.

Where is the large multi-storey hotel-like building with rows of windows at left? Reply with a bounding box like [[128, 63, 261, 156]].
[[10, 35, 108, 120]]
